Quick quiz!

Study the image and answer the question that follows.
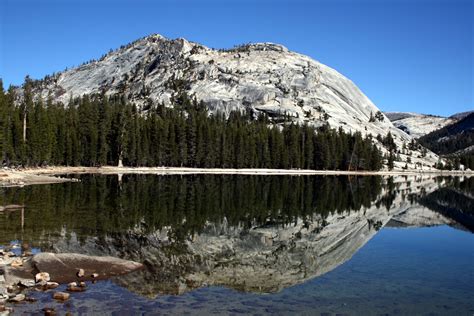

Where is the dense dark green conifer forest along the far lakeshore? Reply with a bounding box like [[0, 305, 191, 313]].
[[0, 80, 382, 170]]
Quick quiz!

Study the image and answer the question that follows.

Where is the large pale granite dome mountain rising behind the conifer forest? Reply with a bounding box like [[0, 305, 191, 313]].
[[18, 35, 438, 167]]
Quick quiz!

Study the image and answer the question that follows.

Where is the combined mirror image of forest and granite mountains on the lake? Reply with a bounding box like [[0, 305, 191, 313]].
[[0, 175, 474, 297]]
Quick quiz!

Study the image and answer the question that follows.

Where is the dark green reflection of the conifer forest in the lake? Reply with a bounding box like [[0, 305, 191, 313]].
[[0, 175, 381, 240]]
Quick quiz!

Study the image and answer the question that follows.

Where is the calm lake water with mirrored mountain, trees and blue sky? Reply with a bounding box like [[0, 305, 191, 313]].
[[0, 175, 474, 315]]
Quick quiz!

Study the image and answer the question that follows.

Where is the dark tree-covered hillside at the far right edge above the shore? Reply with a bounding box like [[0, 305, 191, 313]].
[[420, 113, 474, 155]]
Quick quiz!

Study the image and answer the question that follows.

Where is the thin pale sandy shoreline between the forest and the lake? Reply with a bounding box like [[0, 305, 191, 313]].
[[0, 166, 474, 187]]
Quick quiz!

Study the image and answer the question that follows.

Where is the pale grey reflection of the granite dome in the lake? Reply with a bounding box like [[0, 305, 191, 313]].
[[39, 178, 468, 296]]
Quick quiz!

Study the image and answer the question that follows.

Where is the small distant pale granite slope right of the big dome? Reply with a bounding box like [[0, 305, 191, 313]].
[[385, 112, 460, 138]]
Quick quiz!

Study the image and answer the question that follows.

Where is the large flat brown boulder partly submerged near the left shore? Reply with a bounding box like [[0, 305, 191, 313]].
[[31, 252, 143, 283]]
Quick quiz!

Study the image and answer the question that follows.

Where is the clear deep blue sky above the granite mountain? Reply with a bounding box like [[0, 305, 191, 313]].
[[0, 0, 474, 115]]
